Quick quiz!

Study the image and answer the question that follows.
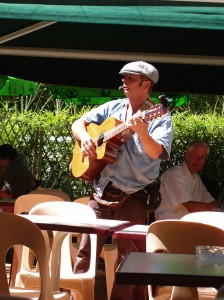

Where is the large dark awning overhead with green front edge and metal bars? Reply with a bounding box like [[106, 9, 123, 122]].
[[0, 0, 224, 94]]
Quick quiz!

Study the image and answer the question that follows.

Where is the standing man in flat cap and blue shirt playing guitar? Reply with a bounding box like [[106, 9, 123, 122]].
[[72, 61, 173, 300]]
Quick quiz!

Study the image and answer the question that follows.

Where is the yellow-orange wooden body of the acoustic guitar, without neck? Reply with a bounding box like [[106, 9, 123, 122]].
[[72, 117, 123, 182]]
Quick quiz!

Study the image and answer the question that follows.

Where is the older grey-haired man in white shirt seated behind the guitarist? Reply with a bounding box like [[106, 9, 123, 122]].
[[155, 140, 220, 220]]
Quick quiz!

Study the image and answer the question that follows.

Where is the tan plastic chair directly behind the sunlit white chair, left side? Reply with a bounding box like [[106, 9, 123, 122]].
[[10, 189, 66, 286]]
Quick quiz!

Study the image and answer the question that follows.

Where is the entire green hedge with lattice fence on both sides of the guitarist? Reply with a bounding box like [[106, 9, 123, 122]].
[[0, 96, 224, 198]]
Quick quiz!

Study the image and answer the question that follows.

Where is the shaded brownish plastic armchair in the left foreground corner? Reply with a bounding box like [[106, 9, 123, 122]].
[[0, 213, 69, 300]]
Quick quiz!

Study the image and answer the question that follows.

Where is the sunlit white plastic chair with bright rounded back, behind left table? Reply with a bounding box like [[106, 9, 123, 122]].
[[16, 201, 97, 300]]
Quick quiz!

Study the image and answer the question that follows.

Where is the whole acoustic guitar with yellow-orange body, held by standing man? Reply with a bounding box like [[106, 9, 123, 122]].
[[71, 98, 170, 182]]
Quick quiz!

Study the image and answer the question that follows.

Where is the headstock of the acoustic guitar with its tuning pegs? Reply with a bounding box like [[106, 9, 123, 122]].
[[141, 95, 172, 120]]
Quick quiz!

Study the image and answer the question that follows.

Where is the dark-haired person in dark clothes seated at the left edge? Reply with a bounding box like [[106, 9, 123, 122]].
[[0, 144, 36, 199]]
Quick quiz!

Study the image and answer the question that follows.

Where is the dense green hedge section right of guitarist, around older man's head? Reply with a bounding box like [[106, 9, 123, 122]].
[[161, 112, 224, 197]]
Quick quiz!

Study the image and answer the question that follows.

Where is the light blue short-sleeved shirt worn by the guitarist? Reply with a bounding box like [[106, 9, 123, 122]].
[[83, 98, 173, 197]]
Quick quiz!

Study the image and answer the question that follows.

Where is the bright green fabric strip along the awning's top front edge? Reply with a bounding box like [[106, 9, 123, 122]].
[[0, 3, 224, 30]]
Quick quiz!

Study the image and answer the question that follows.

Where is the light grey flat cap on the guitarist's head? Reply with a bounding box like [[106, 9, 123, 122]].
[[119, 61, 159, 83]]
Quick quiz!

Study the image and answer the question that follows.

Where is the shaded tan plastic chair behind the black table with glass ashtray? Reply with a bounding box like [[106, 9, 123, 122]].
[[146, 220, 224, 300]]
